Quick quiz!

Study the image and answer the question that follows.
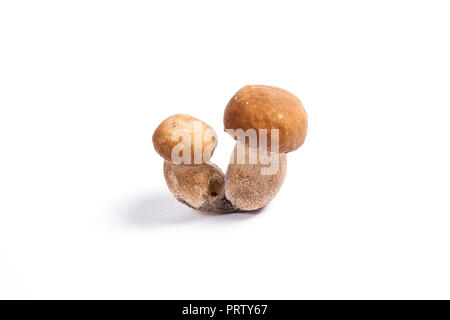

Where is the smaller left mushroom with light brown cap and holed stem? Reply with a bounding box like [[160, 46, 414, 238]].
[[153, 114, 239, 213]]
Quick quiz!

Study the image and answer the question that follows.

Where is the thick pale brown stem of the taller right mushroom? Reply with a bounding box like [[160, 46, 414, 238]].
[[225, 142, 287, 211]]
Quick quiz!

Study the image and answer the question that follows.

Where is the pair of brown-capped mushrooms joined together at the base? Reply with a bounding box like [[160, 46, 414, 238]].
[[153, 85, 308, 213]]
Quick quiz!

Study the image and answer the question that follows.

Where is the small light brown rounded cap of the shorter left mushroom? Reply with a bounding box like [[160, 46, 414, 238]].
[[153, 114, 217, 164]]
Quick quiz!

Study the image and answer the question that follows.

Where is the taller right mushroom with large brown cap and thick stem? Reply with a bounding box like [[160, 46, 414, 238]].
[[224, 85, 308, 211]]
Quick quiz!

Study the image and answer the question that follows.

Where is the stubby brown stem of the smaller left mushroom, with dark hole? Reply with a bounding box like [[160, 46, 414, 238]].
[[164, 161, 239, 213]]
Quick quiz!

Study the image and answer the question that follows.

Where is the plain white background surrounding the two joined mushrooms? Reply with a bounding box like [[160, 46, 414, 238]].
[[0, 1, 450, 299]]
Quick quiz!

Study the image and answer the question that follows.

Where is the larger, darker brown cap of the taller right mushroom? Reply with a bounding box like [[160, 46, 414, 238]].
[[224, 85, 308, 153]]
